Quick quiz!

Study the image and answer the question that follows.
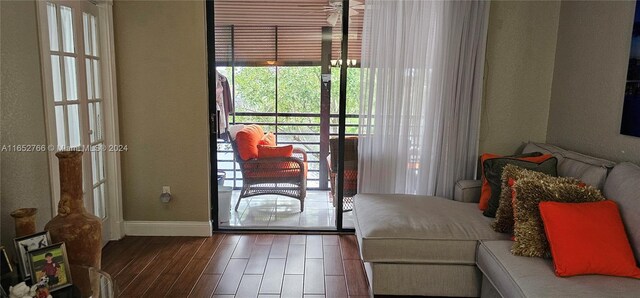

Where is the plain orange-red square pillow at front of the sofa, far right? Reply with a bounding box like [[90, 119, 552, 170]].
[[538, 200, 640, 278]]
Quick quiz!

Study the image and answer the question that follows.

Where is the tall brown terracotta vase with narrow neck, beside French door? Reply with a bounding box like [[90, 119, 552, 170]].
[[45, 151, 102, 268]]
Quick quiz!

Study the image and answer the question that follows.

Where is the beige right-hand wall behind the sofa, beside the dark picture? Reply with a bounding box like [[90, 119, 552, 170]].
[[547, 1, 640, 163]]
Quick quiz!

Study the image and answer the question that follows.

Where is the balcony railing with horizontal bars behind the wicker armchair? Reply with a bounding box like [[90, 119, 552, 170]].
[[218, 112, 359, 189]]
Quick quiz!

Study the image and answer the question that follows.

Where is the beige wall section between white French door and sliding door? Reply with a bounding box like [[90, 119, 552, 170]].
[[113, 1, 209, 221]]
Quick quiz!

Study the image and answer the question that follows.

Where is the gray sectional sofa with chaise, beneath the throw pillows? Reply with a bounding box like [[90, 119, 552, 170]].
[[354, 143, 640, 297]]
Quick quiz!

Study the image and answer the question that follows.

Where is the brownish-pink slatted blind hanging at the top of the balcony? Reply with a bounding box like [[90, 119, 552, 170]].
[[215, 0, 364, 65]]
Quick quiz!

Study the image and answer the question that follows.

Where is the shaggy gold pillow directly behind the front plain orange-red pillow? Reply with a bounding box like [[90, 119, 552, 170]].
[[511, 177, 605, 258]]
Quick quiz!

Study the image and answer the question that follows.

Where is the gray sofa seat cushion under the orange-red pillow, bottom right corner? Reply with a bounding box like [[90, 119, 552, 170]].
[[477, 241, 640, 298]]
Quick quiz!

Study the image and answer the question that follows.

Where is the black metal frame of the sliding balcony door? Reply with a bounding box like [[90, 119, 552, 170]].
[[205, 0, 355, 233]]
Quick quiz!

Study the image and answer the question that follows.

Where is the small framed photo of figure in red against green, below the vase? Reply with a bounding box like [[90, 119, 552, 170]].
[[28, 243, 71, 291]]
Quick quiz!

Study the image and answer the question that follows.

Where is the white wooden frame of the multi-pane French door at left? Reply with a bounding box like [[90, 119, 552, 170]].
[[35, 0, 124, 245]]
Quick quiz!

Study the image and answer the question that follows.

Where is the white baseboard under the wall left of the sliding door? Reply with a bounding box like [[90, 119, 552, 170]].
[[124, 221, 212, 237]]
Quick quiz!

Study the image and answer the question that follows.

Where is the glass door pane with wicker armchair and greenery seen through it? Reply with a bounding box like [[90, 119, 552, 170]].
[[208, 0, 348, 230]]
